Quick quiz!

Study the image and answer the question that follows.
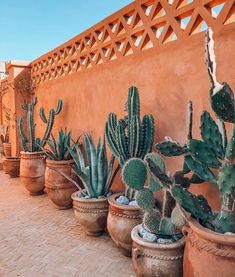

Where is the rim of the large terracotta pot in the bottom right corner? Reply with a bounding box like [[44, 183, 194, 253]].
[[186, 218, 235, 245]]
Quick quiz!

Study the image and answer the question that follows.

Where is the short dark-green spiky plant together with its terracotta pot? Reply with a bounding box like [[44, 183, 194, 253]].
[[40, 129, 78, 210]]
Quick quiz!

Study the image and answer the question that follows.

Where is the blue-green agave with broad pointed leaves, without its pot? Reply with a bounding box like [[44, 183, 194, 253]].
[[59, 134, 120, 198]]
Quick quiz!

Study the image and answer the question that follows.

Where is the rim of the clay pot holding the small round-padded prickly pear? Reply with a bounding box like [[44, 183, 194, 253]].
[[131, 224, 185, 250]]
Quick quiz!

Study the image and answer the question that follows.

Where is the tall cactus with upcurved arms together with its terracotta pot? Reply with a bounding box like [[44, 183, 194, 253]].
[[18, 96, 62, 195]]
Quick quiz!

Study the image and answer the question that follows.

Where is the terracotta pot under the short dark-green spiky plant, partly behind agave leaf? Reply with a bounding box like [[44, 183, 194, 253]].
[[45, 159, 77, 210]]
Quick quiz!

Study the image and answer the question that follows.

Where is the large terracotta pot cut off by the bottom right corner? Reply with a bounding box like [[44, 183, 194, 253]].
[[184, 219, 235, 277]]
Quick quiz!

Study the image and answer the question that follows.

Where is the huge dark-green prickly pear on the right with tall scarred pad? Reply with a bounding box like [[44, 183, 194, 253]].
[[156, 29, 235, 233]]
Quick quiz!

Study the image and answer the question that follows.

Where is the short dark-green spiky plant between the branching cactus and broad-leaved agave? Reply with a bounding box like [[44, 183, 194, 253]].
[[40, 128, 76, 161]]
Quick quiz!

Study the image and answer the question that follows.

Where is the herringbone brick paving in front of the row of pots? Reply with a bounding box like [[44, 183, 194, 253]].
[[0, 171, 134, 277]]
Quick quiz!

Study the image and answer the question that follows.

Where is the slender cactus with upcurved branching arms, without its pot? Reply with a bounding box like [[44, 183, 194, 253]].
[[18, 96, 62, 152]]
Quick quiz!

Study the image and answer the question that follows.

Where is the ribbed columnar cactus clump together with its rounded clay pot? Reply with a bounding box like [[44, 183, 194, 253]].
[[105, 87, 154, 256]]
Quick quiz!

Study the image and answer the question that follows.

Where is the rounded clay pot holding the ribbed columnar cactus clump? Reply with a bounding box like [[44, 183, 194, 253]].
[[107, 193, 143, 256]]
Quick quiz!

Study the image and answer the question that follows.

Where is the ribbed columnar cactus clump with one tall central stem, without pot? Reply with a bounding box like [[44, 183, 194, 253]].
[[105, 87, 154, 199]]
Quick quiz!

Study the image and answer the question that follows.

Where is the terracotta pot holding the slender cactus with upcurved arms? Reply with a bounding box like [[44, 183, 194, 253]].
[[20, 151, 46, 196]]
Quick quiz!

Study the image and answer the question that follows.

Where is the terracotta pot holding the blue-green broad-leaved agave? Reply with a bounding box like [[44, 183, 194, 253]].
[[72, 192, 109, 236]]
